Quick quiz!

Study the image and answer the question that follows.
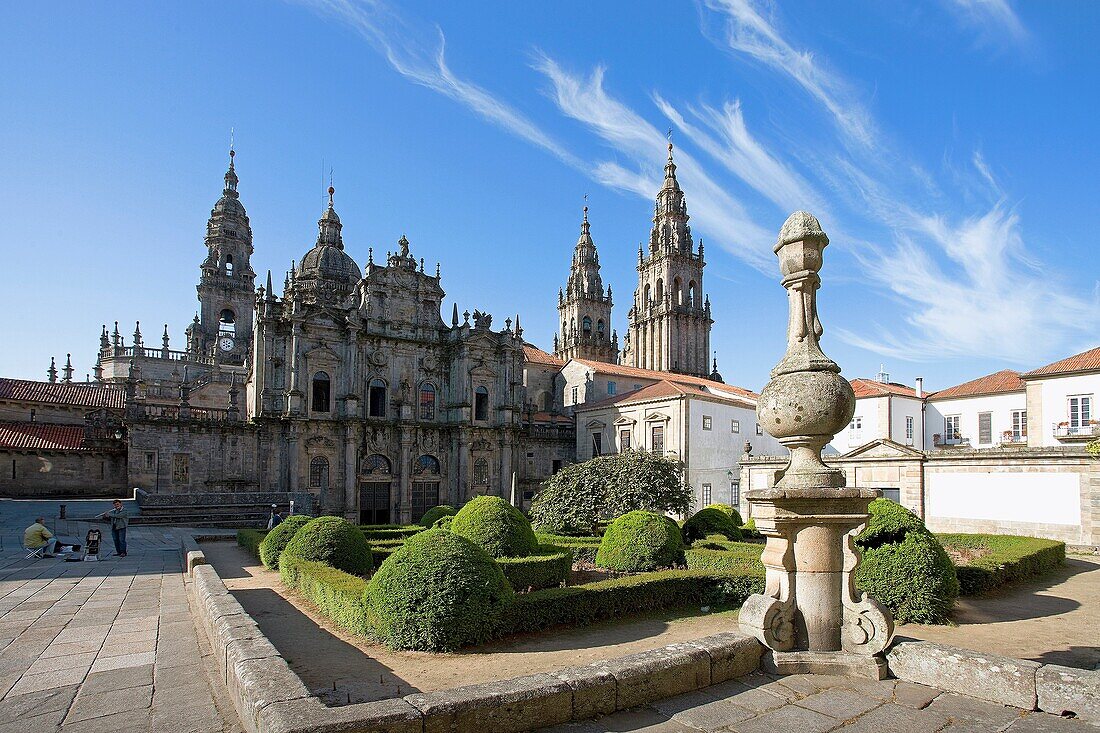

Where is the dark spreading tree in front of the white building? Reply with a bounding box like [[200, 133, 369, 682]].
[[531, 450, 693, 533]]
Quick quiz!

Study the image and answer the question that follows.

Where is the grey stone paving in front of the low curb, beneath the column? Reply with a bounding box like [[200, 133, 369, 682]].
[[543, 674, 1098, 733]]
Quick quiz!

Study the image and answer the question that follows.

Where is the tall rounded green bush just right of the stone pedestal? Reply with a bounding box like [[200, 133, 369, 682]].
[[856, 499, 959, 624]]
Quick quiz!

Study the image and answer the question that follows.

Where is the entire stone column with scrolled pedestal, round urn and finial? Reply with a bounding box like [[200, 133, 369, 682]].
[[740, 211, 893, 679]]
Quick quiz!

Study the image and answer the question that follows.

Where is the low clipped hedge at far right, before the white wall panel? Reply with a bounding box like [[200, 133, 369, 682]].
[[936, 534, 1066, 595]]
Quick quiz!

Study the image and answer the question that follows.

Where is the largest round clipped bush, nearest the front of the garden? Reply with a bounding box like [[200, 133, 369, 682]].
[[363, 529, 513, 652]]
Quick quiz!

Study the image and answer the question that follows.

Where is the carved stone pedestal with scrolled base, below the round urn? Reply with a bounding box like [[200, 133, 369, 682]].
[[740, 489, 893, 679]]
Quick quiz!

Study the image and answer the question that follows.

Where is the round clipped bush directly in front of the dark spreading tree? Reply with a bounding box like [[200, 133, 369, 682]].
[[596, 511, 684, 572]]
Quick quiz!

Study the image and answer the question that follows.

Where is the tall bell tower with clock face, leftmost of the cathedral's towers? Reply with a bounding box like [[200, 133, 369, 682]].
[[188, 149, 256, 362]]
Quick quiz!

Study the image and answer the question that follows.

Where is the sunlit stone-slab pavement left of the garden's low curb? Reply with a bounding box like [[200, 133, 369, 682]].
[[0, 517, 241, 733]]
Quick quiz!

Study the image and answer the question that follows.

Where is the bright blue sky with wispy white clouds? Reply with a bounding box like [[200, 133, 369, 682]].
[[0, 0, 1100, 389]]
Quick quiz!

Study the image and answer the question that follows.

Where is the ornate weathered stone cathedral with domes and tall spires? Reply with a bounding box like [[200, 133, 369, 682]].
[[0, 139, 721, 524]]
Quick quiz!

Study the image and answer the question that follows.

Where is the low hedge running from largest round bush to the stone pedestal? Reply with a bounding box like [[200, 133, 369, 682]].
[[496, 570, 763, 636]]
